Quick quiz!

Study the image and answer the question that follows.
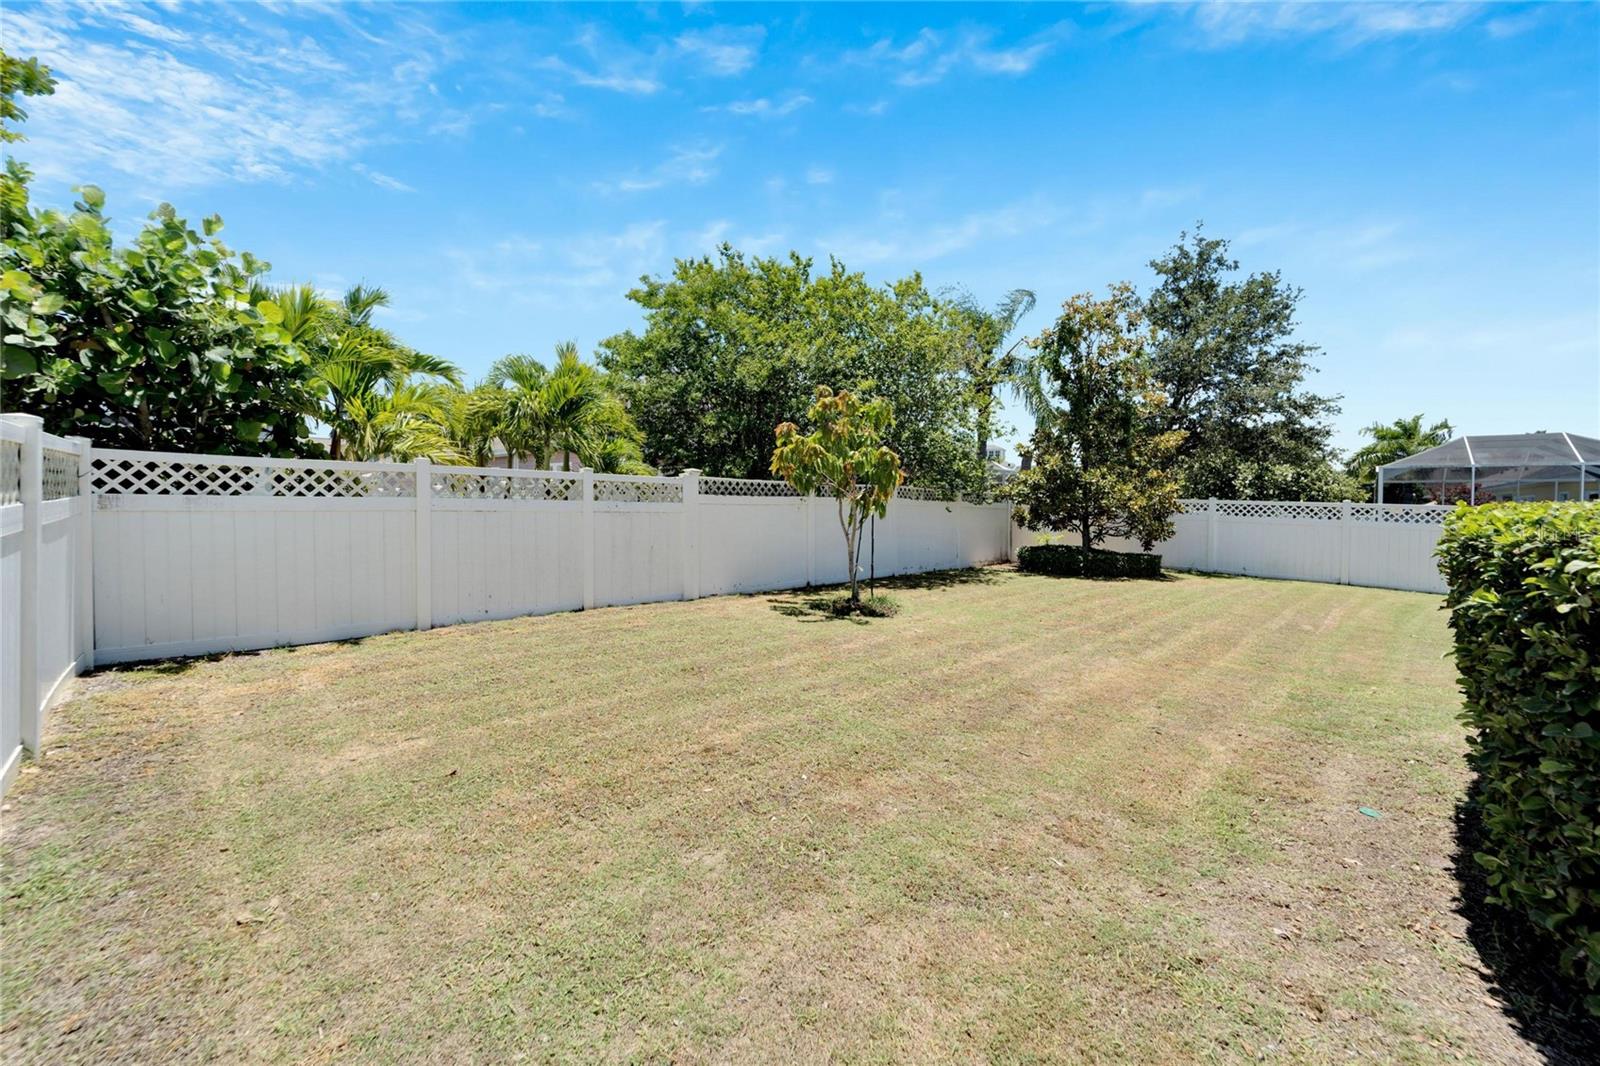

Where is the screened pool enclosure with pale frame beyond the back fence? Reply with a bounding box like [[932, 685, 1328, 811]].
[[1378, 434, 1600, 504]]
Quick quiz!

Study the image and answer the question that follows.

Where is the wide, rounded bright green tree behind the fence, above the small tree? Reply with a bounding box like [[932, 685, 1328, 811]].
[[600, 245, 982, 490]]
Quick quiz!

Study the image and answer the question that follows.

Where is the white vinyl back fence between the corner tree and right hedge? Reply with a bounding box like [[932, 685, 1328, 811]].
[[1013, 499, 1450, 592]]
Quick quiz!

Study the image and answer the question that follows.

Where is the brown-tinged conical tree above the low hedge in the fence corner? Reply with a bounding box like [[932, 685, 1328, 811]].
[[1010, 283, 1184, 551]]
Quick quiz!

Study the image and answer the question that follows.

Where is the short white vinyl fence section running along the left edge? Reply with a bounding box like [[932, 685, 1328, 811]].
[[0, 415, 94, 792]]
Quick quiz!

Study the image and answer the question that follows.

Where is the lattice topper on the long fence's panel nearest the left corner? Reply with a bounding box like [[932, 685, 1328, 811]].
[[90, 453, 416, 499]]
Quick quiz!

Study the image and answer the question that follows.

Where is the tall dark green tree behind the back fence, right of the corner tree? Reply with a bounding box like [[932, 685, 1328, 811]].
[[1144, 230, 1349, 499]]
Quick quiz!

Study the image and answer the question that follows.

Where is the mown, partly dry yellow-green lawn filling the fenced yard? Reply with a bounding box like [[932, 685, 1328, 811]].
[[0, 570, 1536, 1063]]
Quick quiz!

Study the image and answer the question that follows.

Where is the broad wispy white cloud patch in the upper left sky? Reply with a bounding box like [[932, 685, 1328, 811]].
[[5, 5, 454, 195]]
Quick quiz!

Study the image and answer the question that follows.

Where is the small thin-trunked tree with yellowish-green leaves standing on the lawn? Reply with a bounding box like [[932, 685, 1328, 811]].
[[773, 386, 904, 605]]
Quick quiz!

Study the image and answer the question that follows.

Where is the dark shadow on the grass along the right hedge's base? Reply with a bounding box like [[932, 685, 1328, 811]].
[[1454, 778, 1600, 1066]]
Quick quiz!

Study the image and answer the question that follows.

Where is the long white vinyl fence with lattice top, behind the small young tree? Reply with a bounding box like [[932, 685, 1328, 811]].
[[78, 448, 1010, 663]]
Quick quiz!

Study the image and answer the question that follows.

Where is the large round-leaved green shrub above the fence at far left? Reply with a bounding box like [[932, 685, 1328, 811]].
[[0, 171, 312, 455]]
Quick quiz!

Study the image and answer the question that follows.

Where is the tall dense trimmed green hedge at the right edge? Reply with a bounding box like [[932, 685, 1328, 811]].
[[1438, 503, 1600, 1013]]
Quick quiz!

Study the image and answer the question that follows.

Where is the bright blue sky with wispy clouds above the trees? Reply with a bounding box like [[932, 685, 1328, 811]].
[[0, 0, 1600, 448]]
